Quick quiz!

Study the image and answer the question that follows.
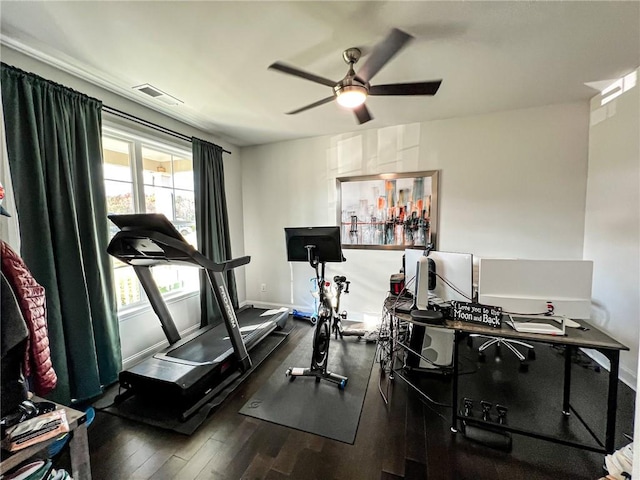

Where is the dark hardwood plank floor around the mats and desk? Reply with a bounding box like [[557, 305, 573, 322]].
[[59, 320, 635, 480]]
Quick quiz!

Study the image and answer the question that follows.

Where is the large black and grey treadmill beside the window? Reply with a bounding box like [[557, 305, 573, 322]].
[[107, 214, 289, 421]]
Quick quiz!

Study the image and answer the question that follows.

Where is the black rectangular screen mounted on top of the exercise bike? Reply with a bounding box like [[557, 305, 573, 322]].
[[284, 226, 345, 262]]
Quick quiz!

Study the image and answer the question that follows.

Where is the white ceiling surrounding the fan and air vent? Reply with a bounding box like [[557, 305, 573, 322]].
[[0, 0, 640, 146]]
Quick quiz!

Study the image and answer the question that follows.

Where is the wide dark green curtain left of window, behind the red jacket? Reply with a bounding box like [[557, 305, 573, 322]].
[[1, 63, 122, 404]]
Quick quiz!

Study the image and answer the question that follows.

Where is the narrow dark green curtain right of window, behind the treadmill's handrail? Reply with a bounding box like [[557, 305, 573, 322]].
[[191, 138, 238, 326]]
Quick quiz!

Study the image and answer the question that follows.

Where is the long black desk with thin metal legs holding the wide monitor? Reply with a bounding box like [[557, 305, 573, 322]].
[[385, 301, 629, 453]]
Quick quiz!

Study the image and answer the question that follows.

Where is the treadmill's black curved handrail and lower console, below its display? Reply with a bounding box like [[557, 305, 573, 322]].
[[107, 229, 251, 272]]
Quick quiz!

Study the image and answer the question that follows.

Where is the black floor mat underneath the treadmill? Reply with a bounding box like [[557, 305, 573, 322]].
[[93, 326, 291, 435]]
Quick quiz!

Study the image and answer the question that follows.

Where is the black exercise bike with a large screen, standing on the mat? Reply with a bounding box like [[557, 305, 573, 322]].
[[285, 227, 349, 390]]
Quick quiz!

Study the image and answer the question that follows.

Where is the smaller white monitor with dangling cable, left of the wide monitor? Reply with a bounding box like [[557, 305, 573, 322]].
[[429, 251, 473, 302]]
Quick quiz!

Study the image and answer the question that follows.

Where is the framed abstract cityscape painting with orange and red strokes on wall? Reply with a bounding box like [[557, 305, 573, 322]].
[[336, 170, 439, 250]]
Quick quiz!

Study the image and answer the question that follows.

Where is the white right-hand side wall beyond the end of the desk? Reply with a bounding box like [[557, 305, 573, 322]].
[[584, 69, 640, 387]]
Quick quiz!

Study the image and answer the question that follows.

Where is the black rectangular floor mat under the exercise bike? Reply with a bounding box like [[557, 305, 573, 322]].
[[240, 327, 376, 444]]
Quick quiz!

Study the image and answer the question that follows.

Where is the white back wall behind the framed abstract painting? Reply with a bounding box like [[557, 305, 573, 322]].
[[242, 103, 589, 319]]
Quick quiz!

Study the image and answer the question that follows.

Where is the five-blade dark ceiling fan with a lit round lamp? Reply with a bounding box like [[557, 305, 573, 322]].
[[269, 28, 442, 124]]
